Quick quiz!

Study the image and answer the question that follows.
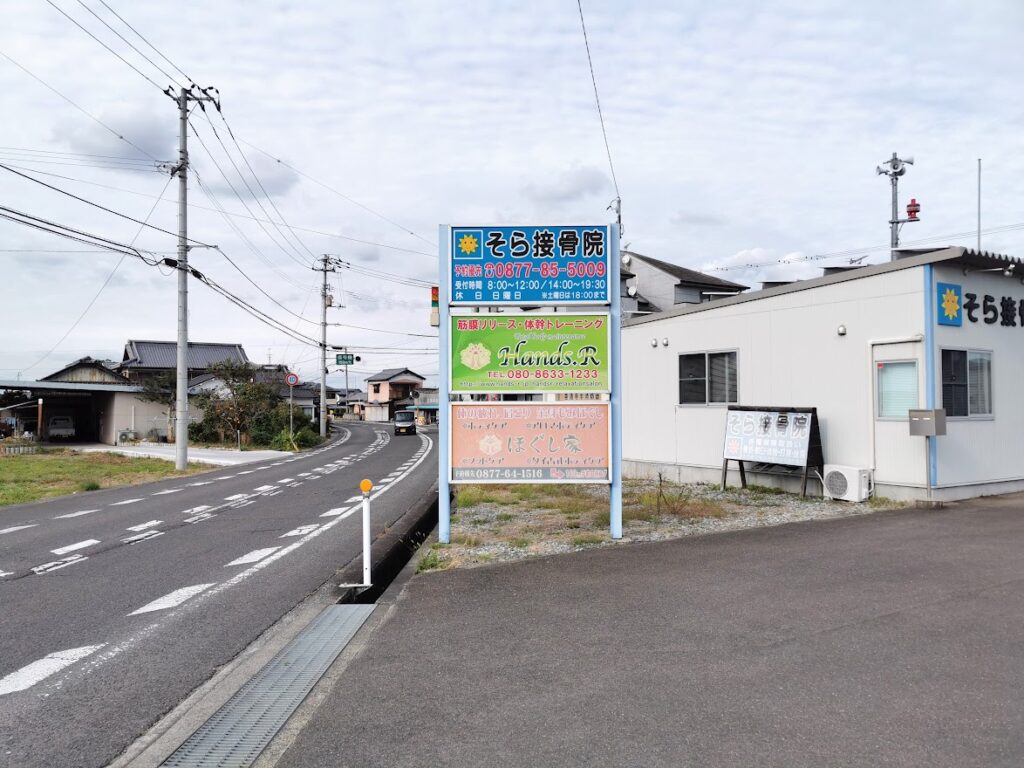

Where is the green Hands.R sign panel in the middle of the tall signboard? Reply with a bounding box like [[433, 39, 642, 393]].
[[451, 312, 611, 393]]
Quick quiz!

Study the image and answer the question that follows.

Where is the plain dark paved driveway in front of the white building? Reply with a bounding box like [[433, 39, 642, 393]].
[[281, 497, 1024, 768]]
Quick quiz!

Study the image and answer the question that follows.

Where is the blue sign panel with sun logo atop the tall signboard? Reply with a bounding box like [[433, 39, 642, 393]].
[[447, 225, 613, 306]]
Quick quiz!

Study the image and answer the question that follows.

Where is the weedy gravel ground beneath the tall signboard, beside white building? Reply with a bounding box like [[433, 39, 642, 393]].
[[420, 480, 902, 570]]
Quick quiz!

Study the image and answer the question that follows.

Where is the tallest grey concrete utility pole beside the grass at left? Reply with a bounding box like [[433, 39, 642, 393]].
[[164, 85, 216, 470]]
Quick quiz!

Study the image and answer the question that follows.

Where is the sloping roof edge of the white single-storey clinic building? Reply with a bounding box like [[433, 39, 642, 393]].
[[624, 246, 1024, 327]]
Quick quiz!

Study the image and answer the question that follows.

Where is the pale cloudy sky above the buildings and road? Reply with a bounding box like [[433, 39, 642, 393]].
[[0, 0, 1024, 387]]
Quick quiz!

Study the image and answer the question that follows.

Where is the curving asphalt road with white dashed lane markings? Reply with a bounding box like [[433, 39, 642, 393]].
[[0, 423, 436, 768]]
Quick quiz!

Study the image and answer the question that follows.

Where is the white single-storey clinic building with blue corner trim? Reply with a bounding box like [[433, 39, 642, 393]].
[[623, 247, 1024, 500]]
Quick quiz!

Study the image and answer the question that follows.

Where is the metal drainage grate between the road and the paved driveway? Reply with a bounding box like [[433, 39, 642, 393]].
[[161, 605, 375, 768]]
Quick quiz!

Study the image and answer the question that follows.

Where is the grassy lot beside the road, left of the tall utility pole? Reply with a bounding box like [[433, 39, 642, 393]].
[[0, 451, 210, 506]]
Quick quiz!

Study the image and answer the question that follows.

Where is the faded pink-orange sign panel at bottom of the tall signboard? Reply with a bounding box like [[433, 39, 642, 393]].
[[451, 402, 611, 482]]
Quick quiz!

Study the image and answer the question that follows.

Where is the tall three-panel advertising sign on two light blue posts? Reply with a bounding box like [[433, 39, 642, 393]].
[[438, 224, 622, 543]]
